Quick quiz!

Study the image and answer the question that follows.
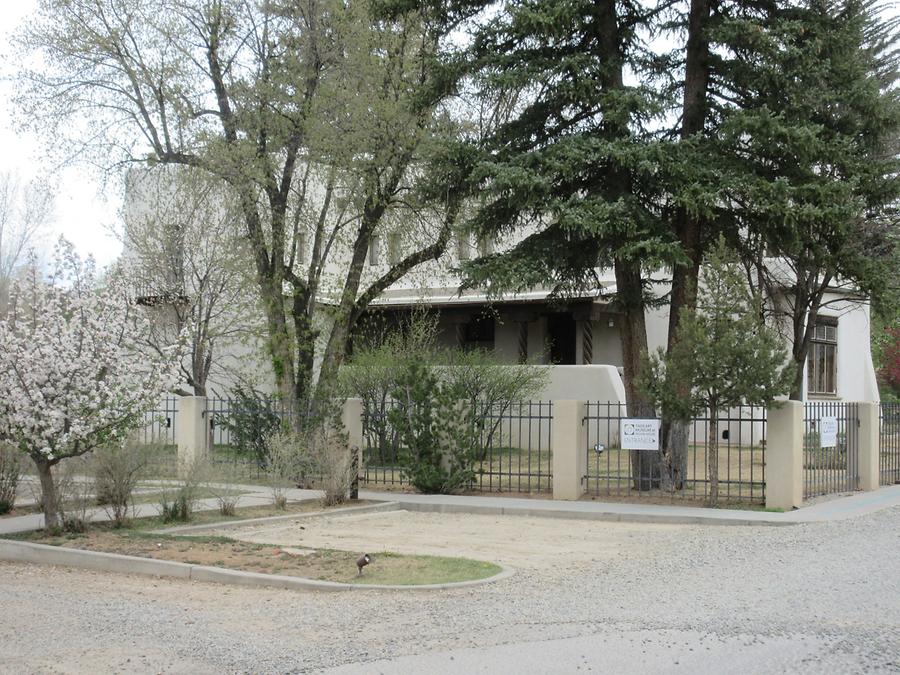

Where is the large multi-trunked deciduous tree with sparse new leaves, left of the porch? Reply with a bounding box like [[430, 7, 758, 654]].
[[19, 0, 464, 418]]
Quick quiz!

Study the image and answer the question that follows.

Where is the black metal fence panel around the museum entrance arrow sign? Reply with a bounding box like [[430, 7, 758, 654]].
[[583, 401, 766, 504]]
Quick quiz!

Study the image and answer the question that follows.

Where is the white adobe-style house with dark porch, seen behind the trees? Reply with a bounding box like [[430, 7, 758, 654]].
[[125, 168, 878, 401]]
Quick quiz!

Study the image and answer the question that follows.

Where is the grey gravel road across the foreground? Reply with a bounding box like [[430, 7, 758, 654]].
[[0, 508, 900, 673]]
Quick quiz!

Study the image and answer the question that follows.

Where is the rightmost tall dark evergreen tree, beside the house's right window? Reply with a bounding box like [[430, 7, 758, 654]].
[[717, 0, 900, 400]]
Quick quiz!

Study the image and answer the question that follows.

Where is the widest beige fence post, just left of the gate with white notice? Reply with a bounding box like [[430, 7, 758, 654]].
[[766, 401, 805, 510]]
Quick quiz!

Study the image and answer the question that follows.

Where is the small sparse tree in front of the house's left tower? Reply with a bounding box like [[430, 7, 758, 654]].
[[121, 166, 262, 396]]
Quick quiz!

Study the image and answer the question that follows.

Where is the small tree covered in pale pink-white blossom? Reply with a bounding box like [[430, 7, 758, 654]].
[[0, 240, 180, 529]]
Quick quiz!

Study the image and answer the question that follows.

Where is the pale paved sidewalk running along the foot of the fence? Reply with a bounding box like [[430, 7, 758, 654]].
[[0, 485, 900, 536]]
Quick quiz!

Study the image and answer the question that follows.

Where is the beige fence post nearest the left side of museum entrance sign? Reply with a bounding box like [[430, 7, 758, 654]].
[[550, 400, 587, 500]]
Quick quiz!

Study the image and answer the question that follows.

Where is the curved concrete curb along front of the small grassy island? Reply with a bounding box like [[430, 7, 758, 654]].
[[0, 539, 514, 591]]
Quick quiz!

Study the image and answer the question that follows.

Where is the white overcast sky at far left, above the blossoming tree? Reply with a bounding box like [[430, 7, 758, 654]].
[[0, 0, 122, 266]]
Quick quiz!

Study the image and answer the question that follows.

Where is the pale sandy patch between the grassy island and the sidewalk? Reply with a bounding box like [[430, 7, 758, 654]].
[[204, 511, 687, 570]]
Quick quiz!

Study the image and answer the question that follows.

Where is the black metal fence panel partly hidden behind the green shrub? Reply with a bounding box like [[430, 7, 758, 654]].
[[360, 401, 553, 493]]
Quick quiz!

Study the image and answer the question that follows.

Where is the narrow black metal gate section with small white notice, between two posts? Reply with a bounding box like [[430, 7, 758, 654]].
[[803, 401, 859, 499]]
